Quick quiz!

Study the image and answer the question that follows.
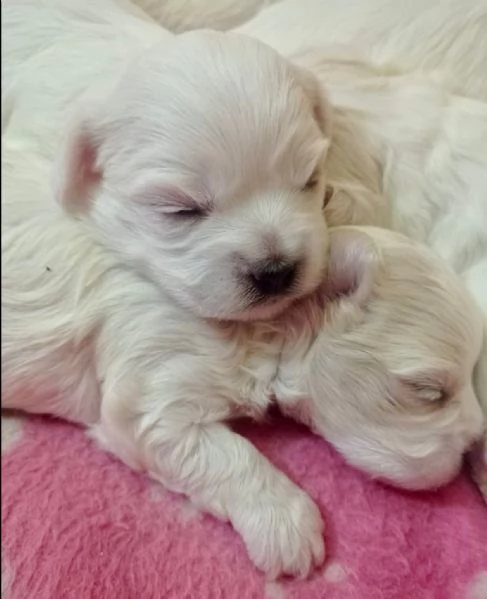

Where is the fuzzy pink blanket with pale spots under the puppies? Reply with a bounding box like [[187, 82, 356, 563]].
[[2, 418, 487, 599]]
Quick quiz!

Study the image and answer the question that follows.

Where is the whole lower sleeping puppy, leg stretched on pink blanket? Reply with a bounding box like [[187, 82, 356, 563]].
[[2, 213, 481, 577]]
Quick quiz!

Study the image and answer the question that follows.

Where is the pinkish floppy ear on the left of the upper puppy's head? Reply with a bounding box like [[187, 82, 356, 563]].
[[53, 118, 102, 214]]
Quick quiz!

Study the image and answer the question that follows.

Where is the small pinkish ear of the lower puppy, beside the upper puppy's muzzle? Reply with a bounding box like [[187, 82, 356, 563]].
[[324, 227, 380, 306]]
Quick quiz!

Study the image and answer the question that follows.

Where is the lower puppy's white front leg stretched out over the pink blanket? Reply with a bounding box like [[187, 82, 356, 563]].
[[95, 384, 324, 578]]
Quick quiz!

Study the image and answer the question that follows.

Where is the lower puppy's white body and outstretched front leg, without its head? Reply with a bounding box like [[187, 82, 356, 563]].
[[2, 207, 324, 576]]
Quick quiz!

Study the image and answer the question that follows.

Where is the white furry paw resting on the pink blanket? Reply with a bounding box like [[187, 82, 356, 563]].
[[234, 483, 325, 579]]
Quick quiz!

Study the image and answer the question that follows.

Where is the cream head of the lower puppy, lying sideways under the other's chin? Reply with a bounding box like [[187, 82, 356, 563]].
[[275, 227, 482, 490]]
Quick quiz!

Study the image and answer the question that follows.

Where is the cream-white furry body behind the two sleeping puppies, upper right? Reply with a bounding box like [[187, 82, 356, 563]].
[[129, 0, 487, 434]]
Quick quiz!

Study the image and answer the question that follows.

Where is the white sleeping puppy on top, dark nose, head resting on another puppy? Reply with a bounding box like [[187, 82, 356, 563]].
[[2, 0, 329, 320]]
